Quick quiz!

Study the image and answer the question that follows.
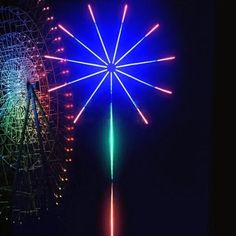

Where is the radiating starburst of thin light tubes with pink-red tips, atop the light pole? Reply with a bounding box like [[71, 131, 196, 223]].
[[47, 5, 175, 124]]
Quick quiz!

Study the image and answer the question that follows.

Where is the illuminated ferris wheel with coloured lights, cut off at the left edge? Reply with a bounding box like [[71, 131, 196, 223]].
[[0, 0, 74, 223]]
